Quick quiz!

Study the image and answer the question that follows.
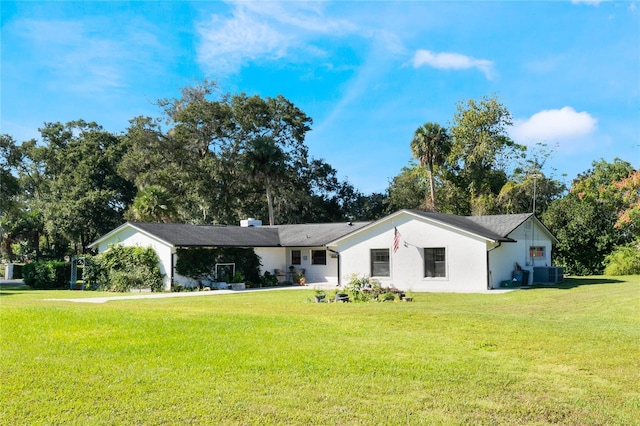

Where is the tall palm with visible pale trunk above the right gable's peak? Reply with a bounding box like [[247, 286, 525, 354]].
[[411, 123, 451, 210]]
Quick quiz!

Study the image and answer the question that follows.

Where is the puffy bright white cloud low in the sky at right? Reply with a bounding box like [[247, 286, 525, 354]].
[[509, 106, 598, 144]]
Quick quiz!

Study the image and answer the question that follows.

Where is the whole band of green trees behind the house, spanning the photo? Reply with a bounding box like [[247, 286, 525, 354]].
[[0, 88, 640, 274]]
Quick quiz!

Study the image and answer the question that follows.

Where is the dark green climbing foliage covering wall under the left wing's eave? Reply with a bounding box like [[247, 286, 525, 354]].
[[176, 247, 260, 285]]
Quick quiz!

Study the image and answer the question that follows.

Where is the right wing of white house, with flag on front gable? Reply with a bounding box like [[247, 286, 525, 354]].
[[328, 210, 557, 292]]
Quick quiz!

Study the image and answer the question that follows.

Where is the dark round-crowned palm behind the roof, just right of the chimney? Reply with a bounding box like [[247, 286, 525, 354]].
[[245, 136, 287, 226]]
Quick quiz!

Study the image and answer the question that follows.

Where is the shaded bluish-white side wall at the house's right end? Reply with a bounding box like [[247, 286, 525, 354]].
[[489, 219, 553, 288]]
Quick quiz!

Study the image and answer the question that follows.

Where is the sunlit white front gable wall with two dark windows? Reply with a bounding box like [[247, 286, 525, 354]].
[[338, 215, 487, 292]]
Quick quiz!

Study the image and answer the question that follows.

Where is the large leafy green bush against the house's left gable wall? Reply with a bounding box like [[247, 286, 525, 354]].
[[83, 245, 164, 293]]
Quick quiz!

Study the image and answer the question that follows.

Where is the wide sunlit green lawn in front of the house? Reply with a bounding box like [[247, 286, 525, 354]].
[[0, 276, 640, 425]]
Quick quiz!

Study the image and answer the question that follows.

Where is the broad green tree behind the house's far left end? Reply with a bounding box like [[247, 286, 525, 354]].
[[18, 120, 134, 254]]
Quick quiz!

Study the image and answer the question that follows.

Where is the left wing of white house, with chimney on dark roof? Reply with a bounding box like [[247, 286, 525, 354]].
[[89, 219, 368, 290]]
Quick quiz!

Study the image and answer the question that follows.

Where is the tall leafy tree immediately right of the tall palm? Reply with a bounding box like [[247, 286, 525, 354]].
[[448, 93, 525, 214]]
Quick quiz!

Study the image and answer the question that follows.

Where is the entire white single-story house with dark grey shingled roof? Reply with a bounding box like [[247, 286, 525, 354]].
[[91, 210, 557, 292]]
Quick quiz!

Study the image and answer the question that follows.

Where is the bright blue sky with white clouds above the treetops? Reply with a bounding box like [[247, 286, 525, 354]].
[[0, 0, 640, 193]]
